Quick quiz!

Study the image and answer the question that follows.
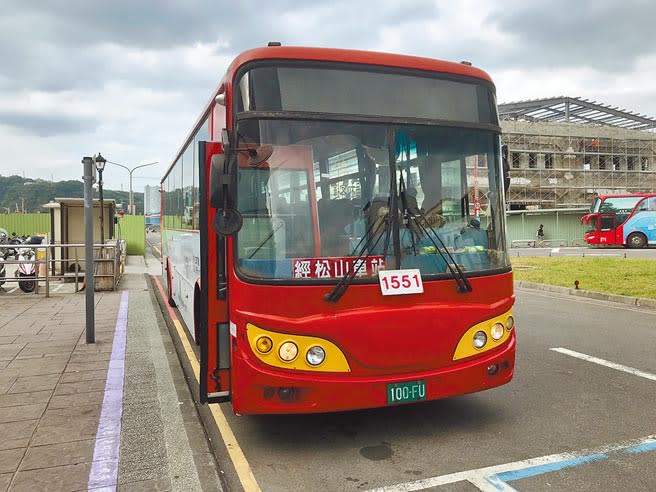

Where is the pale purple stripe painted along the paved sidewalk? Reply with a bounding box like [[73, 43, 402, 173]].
[[87, 291, 128, 492]]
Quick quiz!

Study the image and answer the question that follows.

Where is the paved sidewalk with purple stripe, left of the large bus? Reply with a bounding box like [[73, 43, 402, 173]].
[[0, 257, 221, 492]]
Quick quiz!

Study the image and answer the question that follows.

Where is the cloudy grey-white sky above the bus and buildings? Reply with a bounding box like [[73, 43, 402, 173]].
[[0, 0, 656, 191]]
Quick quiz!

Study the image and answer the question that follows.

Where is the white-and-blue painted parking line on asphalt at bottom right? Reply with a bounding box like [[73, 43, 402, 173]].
[[367, 435, 656, 492]]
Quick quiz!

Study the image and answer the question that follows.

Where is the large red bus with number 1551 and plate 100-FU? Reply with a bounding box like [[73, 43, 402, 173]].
[[161, 45, 515, 414]]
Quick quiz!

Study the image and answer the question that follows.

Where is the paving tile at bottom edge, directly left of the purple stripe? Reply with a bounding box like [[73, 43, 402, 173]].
[[10, 463, 91, 492]]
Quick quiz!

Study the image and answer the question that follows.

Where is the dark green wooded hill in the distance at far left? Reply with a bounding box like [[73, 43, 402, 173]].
[[0, 175, 143, 214]]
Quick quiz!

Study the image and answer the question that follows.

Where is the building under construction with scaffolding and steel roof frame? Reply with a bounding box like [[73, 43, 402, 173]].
[[499, 97, 656, 210]]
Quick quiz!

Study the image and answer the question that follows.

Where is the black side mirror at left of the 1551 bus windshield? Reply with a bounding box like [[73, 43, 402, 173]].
[[210, 154, 243, 236]]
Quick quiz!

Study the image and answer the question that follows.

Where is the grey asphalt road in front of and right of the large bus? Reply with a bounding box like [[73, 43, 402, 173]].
[[209, 290, 656, 492]]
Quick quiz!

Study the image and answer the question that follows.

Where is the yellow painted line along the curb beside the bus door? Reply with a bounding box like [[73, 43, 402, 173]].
[[152, 275, 261, 492]]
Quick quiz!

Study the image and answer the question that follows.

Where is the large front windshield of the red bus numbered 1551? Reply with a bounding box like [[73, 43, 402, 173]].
[[236, 117, 509, 281]]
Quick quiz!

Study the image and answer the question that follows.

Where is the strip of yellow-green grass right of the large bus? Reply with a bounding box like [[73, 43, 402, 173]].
[[512, 256, 656, 299]]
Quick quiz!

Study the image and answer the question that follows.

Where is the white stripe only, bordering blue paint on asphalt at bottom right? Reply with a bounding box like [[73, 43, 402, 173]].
[[367, 434, 656, 492]]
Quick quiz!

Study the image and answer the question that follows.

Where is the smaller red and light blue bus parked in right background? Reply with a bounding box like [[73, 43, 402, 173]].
[[581, 193, 656, 248]]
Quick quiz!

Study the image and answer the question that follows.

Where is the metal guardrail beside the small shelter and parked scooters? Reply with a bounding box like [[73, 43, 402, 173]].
[[0, 241, 126, 297]]
